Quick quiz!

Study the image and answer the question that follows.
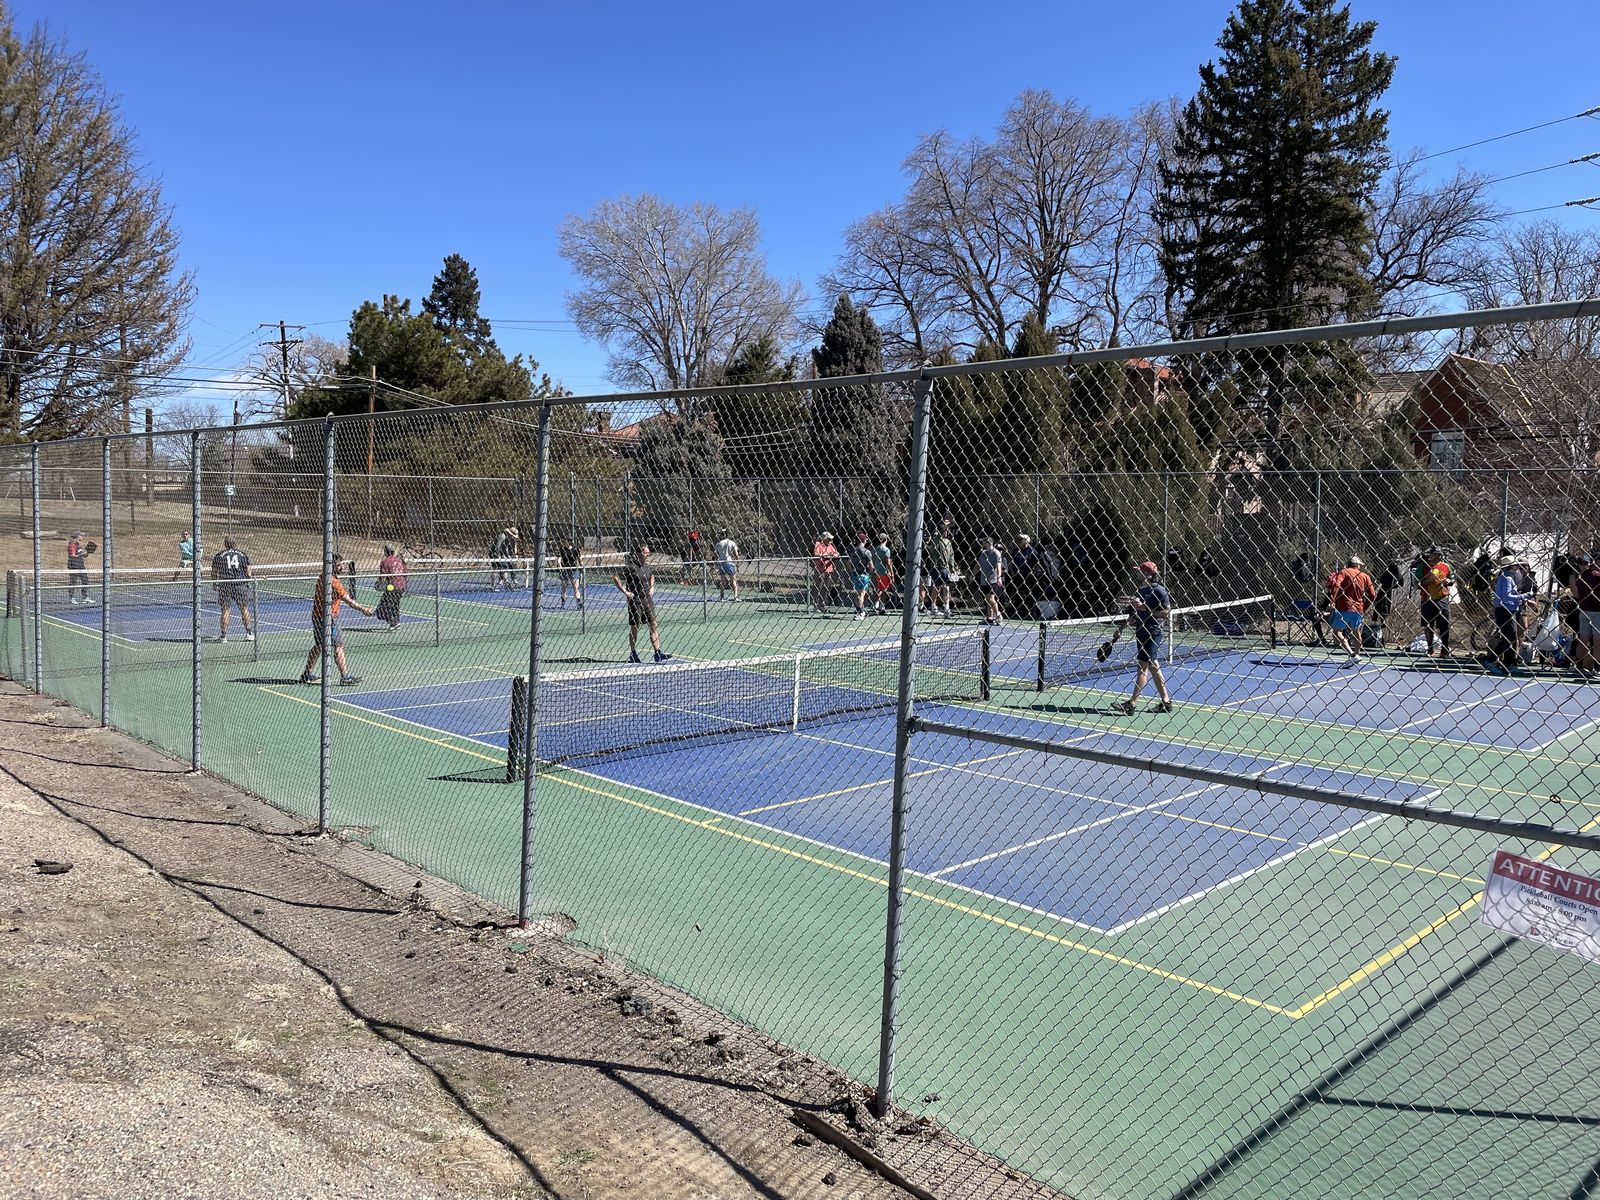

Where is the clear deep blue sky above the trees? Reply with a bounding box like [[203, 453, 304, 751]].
[[10, 0, 1600, 409]]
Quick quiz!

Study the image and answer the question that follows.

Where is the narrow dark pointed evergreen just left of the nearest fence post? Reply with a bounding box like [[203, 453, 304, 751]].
[[805, 296, 910, 536]]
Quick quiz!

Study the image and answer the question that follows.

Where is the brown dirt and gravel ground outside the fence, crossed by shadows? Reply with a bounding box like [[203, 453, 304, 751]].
[[0, 685, 1037, 1200]]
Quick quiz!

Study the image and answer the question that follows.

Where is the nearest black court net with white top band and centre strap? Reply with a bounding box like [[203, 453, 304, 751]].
[[510, 629, 989, 763]]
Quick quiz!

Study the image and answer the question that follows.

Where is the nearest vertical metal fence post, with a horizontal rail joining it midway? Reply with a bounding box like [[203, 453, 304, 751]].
[[874, 379, 933, 1117]]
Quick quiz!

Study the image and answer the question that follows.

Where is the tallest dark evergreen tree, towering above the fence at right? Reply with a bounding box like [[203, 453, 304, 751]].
[[1157, 0, 1394, 440]]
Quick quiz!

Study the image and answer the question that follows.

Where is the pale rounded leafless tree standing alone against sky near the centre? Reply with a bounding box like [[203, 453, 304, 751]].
[[560, 195, 800, 389]]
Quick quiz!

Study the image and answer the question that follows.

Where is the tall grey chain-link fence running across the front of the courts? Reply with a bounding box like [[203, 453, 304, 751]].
[[0, 302, 1600, 1197]]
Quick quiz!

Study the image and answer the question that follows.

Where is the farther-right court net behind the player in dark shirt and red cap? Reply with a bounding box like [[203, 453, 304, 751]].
[[1035, 595, 1274, 691]]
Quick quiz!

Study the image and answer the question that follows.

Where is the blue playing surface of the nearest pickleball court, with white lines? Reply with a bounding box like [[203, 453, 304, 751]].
[[336, 678, 1434, 934]]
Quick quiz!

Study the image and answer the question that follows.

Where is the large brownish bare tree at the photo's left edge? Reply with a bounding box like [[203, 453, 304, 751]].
[[0, 10, 194, 438]]
